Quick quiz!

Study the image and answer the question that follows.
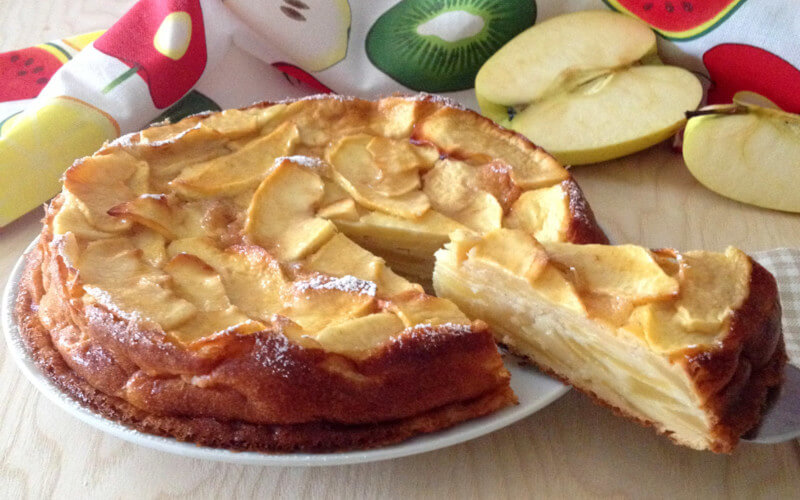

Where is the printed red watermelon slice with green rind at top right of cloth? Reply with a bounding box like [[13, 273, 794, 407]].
[[603, 0, 745, 40]]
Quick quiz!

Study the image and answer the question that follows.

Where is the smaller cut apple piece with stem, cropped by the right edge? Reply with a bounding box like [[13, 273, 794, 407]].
[[683, 93, 800, 212]]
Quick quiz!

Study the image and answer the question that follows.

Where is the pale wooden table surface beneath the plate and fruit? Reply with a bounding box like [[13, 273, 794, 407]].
[[0, 0, 800, 498]]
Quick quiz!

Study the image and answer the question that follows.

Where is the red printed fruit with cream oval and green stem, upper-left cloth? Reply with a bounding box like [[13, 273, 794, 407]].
[[94, 0, 207, 109]]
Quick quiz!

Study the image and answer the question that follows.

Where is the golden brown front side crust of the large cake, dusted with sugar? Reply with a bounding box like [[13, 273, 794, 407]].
[[17, 155, 516, 452]]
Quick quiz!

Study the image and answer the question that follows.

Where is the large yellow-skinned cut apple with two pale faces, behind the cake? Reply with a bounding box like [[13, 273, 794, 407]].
[[475, 11, 703, 165]]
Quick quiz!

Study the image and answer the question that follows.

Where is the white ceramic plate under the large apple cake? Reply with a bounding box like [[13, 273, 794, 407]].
[[0, 241, 568, 466]]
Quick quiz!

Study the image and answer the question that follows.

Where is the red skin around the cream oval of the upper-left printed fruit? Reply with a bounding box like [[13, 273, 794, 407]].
[[94, 0, 207, 109]]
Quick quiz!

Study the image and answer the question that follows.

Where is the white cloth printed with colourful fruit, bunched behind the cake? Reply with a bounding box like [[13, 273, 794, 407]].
[[0, 0, 800, 226]]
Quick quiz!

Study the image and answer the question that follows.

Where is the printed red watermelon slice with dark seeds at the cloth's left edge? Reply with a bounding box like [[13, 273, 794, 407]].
[[0, 45, 69, 102]]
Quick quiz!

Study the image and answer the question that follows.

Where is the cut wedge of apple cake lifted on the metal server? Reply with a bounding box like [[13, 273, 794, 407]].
[[434, 229, 786, 452]]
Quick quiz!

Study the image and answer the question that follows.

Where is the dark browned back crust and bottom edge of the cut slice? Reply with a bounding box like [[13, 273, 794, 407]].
[[501, 258, 787, 453]]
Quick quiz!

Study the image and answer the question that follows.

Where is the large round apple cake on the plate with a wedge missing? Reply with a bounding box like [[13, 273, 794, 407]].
[[17, 96, 607, 451]]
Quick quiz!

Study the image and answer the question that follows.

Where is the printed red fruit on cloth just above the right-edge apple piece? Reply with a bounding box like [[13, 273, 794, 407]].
[[703, 43, 800, 113]]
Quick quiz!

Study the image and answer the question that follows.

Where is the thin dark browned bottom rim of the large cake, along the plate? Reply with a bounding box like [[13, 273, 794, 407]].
[[16, 244, 516, 453]]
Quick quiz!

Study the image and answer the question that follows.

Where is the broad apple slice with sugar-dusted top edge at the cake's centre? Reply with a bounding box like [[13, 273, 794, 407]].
[[244, 159, 336, 261]]
